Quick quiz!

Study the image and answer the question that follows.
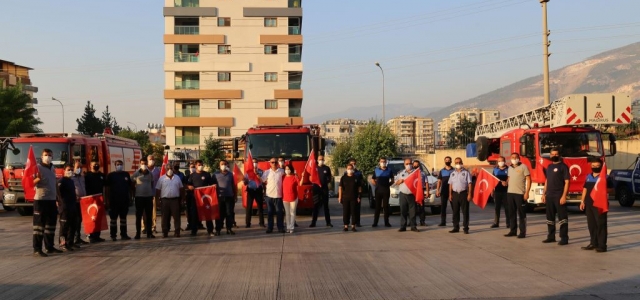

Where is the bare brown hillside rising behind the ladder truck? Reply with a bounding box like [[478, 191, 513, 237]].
[[428, 43, 640, 122]]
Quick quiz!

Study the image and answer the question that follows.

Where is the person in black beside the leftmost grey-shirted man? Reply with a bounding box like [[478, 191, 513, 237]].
[[58, 165, 80, 252]]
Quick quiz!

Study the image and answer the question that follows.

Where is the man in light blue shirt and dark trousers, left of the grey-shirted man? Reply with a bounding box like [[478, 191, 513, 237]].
[[449, 157, 472, 234]]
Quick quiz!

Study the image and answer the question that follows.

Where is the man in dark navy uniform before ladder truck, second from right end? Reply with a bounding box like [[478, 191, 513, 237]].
[[542, 148, 569, 246]]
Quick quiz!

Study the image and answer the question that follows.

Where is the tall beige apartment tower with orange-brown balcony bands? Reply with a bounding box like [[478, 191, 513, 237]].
[[163, 0, 303, 148]]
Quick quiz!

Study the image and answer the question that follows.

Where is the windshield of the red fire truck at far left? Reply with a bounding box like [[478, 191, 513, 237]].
[[5, 142, 69, 168]]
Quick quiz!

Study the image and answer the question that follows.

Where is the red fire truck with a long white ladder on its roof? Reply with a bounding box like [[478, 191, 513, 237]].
[[468, 94, 632, 211]]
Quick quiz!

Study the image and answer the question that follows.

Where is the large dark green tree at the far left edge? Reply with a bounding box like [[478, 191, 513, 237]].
[[0, 82, 42, 136]]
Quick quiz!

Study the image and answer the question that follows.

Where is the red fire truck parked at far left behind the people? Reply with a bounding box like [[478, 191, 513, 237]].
[[2, 133, 142, 216]]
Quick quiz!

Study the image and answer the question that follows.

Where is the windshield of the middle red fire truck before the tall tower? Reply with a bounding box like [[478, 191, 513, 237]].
[[247, 133, 311, 159]]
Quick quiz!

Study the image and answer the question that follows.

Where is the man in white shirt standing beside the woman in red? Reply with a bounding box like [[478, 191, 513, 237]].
[[262, 157, 284, 233]]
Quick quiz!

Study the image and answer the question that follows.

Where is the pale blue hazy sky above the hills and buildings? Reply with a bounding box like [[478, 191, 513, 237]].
[[0, 0, 640, 132]]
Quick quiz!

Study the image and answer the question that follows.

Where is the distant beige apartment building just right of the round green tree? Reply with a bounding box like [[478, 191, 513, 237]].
[[387, 116, 435, 153]]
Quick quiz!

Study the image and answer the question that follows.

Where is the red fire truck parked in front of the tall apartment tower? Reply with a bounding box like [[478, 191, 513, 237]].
[[233, 125, 325, 212]]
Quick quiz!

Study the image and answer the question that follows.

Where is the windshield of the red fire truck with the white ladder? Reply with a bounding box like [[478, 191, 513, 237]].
[[538, 132, 603, 157]]
